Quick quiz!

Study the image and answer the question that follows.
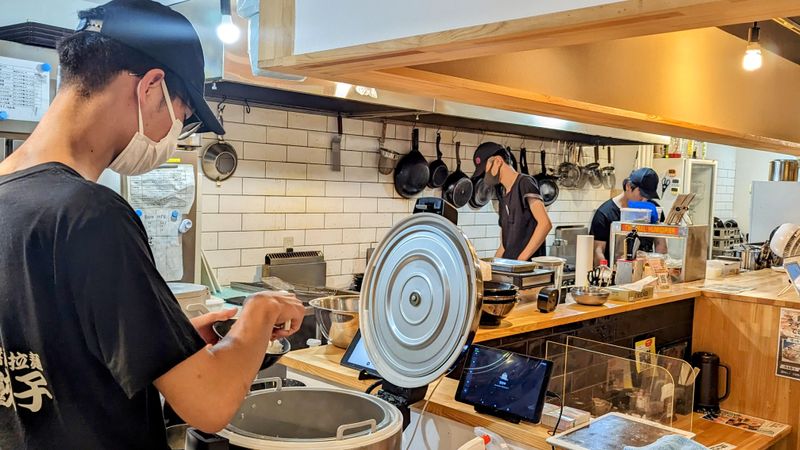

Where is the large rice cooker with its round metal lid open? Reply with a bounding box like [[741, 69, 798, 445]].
[[186, 213, 484, 450]]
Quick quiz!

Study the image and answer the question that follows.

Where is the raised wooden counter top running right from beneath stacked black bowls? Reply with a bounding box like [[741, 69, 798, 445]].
[[475, 285, 701, 342]]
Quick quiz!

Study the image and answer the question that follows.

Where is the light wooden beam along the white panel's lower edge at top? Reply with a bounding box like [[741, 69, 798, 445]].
[[259, 0, 800, 79]]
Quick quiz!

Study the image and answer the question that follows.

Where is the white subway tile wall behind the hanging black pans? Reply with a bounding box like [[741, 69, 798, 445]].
[[200, 104, 612, 287]]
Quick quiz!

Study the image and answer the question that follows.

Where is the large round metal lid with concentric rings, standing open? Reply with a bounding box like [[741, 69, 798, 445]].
[[359, 213, 483, 388]]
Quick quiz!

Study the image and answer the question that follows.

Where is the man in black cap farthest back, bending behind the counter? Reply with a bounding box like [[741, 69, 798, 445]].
[[589, 167, 667, 266]]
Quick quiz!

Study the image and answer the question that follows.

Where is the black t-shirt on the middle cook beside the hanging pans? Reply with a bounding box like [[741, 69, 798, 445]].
[[499, 174, 545, 259]]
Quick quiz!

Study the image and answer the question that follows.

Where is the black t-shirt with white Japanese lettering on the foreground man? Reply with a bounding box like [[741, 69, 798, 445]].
[[0, 163, 204, 450]]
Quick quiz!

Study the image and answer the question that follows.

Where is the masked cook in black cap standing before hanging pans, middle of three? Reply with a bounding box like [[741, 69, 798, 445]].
[[473, 142, 553, 261]]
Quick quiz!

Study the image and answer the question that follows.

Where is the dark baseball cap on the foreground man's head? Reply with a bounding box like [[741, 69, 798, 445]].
[[76, 0, 225, 135]]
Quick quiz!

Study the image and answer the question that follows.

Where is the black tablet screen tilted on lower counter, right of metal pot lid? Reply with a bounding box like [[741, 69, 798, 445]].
[[456, 345, 552, 422]]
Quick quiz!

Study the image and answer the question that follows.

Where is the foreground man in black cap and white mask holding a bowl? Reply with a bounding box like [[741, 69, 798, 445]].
[[0, 0, 304, 449]]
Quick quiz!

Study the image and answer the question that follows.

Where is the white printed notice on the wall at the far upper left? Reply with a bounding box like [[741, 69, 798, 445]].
[[0, 56, 50, 122]]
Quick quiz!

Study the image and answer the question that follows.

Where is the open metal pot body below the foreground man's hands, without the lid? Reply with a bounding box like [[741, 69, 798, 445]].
[[187, 379, 403, 450]]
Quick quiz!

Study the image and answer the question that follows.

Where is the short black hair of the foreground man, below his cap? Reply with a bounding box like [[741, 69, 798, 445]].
[[58, 6, 189, 104]]
